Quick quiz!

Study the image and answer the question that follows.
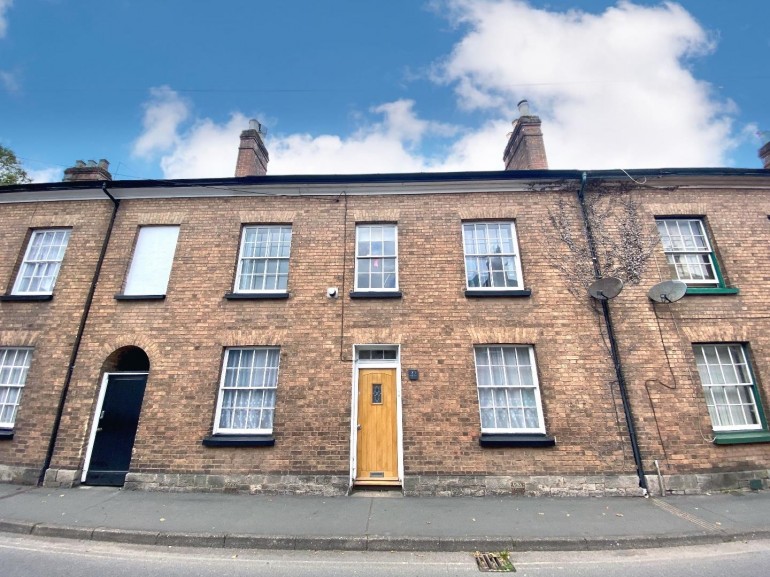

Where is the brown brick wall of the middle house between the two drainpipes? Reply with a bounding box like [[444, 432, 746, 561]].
[[46, 193, 633, 475]]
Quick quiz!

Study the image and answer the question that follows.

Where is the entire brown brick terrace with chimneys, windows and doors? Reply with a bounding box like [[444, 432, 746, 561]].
[[0, 108, 770, 495]]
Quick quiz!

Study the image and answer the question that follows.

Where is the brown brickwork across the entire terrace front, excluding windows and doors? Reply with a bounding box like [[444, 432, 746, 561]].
[[0, 173, 770, 494]]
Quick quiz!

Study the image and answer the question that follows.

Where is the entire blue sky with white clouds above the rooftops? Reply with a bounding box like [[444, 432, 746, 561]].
[[0, 0, 770, 181]]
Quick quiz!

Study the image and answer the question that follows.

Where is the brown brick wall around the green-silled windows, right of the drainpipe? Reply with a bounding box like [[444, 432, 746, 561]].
[[611, 186, 770, 473]]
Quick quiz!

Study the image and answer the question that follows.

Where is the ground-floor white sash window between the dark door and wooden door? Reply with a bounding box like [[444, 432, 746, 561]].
[[214, 347, 280, 434]]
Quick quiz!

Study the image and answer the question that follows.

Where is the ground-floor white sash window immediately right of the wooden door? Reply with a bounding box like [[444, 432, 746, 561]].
[[475, 345, 545, 433]]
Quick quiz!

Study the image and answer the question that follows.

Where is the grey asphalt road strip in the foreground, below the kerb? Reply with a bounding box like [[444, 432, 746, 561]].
[[0, 534, 770, 577]]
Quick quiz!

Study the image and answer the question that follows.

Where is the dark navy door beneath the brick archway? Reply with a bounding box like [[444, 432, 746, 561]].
[[85, 374, 147, 487]]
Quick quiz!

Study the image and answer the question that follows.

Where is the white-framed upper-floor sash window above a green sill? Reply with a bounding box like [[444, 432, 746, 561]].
[[655, 218, 720, 286]]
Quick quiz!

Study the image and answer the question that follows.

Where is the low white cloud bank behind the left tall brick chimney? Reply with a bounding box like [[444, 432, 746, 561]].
[[133, 87, 456, 178]]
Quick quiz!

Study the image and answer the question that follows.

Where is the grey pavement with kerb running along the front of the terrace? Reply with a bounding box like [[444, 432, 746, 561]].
[[0, 484, 770, 551]]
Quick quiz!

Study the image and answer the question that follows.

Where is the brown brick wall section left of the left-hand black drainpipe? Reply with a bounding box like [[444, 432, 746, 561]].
[[0, 199, 112, 482]]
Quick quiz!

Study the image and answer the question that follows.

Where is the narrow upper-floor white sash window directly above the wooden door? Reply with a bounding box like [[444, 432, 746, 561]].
[[355, 224, 398, 291]]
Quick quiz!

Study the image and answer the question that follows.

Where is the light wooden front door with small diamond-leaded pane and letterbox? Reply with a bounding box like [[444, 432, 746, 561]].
[[356, 369, 399, 485]]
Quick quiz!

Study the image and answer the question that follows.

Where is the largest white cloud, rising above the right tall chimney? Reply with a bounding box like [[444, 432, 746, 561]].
[[438, 0, 736, 169]]
